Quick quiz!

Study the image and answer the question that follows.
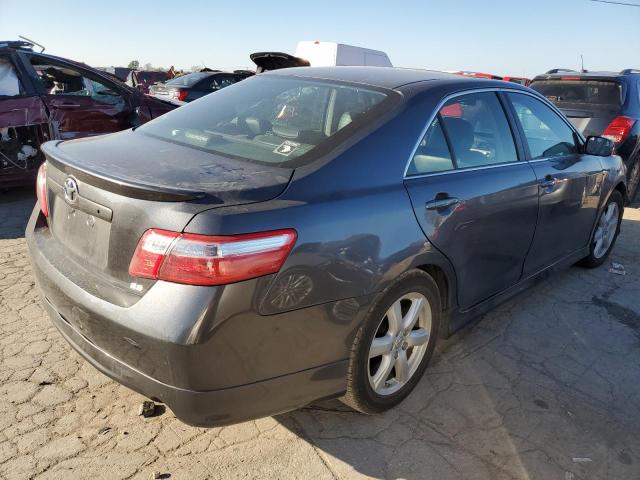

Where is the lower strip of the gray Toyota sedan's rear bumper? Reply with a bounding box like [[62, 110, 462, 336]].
[[44, 300, 348, 427]]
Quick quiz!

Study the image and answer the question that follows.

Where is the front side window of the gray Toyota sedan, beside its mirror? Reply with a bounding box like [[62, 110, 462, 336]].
[[507, 93, 578, 159]]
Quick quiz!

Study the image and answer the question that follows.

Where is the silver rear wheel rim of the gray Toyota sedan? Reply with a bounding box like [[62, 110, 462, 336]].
[[368, 293, 431, 395]]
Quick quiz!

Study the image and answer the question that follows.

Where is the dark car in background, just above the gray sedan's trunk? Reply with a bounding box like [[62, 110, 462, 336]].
[[149, 70, 250, 103]]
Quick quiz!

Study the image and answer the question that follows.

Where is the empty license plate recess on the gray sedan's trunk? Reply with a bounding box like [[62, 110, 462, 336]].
[[49, 195, 111, 269]]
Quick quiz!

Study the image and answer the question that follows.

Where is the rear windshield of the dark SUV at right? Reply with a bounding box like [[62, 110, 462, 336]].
[[531, 80, 621, 107]]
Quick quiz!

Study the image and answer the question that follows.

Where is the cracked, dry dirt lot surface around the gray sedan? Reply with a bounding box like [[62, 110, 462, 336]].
[[0, 191, 640, 480]]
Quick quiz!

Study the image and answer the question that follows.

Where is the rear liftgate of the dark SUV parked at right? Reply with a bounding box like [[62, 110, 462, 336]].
[[531, 77, 623, 137]]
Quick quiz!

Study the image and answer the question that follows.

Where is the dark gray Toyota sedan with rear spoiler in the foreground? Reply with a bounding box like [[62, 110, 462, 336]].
[[26, 67, 627, 425]]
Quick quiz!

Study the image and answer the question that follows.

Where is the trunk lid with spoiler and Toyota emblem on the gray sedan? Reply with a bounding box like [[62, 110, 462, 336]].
[[37, 131, 293, 298]]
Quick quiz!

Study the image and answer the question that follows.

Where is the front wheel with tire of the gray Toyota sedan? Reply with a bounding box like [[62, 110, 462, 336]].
[[580, 190, 624, 268]]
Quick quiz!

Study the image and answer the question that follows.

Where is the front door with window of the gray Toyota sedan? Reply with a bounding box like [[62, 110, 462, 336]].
[[507, 93, 605, 275]]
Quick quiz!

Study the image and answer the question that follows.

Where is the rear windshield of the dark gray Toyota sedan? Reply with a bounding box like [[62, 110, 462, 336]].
[[136, 75, 396, 166]]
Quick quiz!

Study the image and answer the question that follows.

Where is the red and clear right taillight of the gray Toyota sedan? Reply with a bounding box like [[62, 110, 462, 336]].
[[129, 229, 297, 285]]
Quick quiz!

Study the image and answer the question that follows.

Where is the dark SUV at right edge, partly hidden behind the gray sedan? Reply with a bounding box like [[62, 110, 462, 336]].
[[531, 69, 640, 199]]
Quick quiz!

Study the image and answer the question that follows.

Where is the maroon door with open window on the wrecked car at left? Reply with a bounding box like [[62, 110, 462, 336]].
[[26, 54, 133, 140]]
